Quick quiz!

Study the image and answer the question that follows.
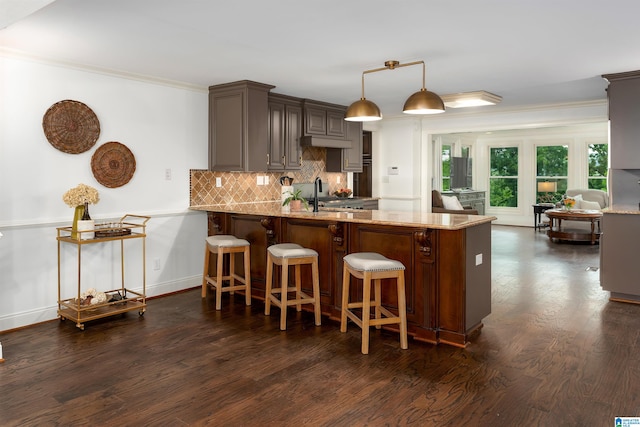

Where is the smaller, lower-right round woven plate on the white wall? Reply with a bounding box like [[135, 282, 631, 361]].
[[91, 142, 136, 188]]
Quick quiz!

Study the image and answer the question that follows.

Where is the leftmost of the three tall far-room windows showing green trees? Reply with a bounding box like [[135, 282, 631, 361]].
[[489, 147, 518, 208]]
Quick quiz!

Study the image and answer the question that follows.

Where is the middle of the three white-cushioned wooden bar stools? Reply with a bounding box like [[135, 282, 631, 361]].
[[264, 243, 321, 331]]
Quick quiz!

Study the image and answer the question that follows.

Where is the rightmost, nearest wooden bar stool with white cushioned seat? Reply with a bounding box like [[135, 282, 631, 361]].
[[340, 252, 409, 354]]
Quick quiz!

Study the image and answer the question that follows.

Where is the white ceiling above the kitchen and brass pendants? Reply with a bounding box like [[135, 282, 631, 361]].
[[0, 0, 640, 117]]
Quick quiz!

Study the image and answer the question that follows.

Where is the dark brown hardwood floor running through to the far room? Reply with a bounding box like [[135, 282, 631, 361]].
[[0, 226, 640, 426]]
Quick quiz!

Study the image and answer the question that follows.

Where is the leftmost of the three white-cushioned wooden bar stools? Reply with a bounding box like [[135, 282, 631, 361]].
[[202, 234, 251, 310]]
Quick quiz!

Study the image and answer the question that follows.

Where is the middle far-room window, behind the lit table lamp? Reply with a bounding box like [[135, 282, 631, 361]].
[[536, 145, 569, 203]]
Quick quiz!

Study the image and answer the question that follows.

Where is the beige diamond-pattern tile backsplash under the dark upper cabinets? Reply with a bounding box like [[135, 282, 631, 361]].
[[189, 147, 347, 206]]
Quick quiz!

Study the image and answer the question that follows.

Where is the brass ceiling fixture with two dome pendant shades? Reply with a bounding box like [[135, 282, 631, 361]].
[[345, 61, 444, 122]]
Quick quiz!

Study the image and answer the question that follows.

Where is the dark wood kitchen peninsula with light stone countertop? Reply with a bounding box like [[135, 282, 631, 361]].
[[190, 202, 495, 347]]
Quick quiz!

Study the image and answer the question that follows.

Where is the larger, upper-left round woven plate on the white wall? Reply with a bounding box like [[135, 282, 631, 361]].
[[42, 99, 100, 154]]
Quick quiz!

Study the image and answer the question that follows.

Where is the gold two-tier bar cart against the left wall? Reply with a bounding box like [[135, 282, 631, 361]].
[[56, 214, 150, 330]]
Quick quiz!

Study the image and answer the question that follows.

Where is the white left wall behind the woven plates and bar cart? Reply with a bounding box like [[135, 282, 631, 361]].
[[0, 55, 208, 331]]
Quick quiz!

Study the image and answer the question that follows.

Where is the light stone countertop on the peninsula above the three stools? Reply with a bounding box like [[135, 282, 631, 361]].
[[189, 202, 497, 230]]
